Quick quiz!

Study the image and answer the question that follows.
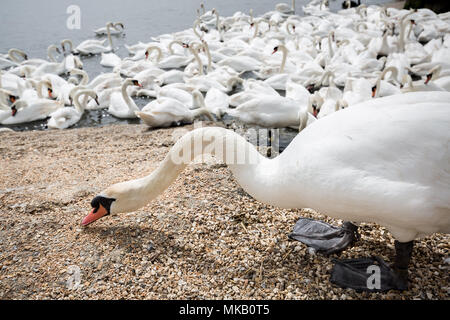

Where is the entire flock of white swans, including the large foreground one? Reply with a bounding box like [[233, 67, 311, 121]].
[[0, 0, 450, 288]]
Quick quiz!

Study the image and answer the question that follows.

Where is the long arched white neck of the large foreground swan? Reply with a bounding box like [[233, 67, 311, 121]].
[[106, 127, 282, 212]]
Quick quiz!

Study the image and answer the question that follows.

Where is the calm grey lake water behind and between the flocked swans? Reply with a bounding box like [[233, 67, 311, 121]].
[[0, 0, 391, 147]]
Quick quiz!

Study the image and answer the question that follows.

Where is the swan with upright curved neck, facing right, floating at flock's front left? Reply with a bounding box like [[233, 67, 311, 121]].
[[108, 79, 142, 119]]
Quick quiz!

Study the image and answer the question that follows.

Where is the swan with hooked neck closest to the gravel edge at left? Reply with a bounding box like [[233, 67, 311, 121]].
[[47, 90, 98, 129]]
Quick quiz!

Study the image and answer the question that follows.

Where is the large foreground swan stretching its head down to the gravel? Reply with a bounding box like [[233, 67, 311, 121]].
[[82, 92, 450, 280]]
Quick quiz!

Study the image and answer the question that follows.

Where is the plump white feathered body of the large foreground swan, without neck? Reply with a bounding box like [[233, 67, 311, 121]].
[[279, 92, 450, 239]]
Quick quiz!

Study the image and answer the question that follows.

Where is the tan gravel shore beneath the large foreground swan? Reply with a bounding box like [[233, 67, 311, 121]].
[[0, 125, 450, 299]]
